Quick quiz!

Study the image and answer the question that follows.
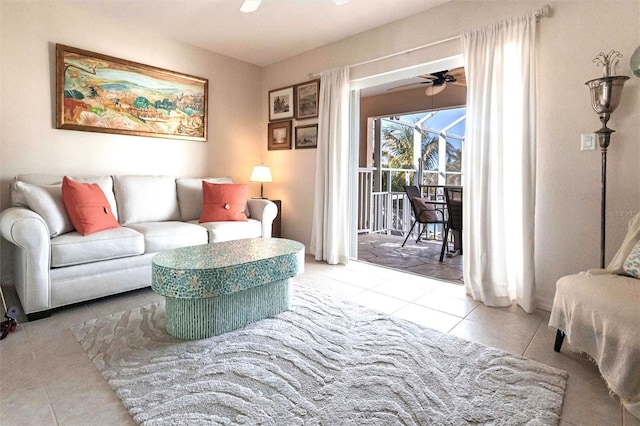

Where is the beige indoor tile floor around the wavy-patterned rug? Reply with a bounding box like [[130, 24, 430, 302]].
[[0, 257, 640, 426]]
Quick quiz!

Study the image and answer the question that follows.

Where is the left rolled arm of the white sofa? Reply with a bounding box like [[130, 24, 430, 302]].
[[0, 207, 51, 314]]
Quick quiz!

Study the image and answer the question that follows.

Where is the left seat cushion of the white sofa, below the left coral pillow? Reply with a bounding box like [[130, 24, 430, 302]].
[[51, 227, 144, 268]]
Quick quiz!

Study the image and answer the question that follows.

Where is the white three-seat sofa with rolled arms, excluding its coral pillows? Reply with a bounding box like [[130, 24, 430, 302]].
[[0, 174, 277, 320]]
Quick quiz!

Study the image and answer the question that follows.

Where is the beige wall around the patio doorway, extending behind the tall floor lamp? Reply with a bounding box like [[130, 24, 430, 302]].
[[262, 0, 640, 308]]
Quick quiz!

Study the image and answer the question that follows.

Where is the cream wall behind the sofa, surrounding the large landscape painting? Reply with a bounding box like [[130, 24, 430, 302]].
[[0, 0, 266, 282]]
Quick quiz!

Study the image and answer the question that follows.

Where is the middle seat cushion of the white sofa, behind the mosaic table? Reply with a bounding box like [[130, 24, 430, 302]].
[[128, 221, 209, 253]]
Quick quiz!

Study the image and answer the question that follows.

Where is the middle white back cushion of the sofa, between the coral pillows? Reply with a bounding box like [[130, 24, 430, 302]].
[[113, 175, 180, 225]]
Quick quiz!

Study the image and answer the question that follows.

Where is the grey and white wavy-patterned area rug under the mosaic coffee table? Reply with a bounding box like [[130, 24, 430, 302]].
[[72, 286, 567, 425]]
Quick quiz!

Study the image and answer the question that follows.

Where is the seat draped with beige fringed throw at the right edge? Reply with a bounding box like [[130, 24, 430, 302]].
[[549, 214, 640, 418]]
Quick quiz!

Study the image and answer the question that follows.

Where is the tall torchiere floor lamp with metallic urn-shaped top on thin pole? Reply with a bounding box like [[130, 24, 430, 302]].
[[585, 50, 629, 269]]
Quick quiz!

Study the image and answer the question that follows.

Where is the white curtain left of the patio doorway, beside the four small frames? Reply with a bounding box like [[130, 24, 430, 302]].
[[310, 67, 349, 265]]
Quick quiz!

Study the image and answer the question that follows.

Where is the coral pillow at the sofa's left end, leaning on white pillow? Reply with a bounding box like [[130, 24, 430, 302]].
[[62, 176, 120, 235]]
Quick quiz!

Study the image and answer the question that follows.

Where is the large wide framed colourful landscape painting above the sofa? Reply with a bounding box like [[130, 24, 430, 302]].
[[56, 44, 208, 141]]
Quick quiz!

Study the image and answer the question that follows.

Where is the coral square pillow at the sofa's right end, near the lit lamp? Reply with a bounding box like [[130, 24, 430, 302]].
[[200, 181, 249, 223]]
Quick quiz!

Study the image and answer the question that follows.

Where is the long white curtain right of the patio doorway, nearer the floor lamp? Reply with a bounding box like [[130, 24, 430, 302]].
[[462, 14, 536, 312]]
